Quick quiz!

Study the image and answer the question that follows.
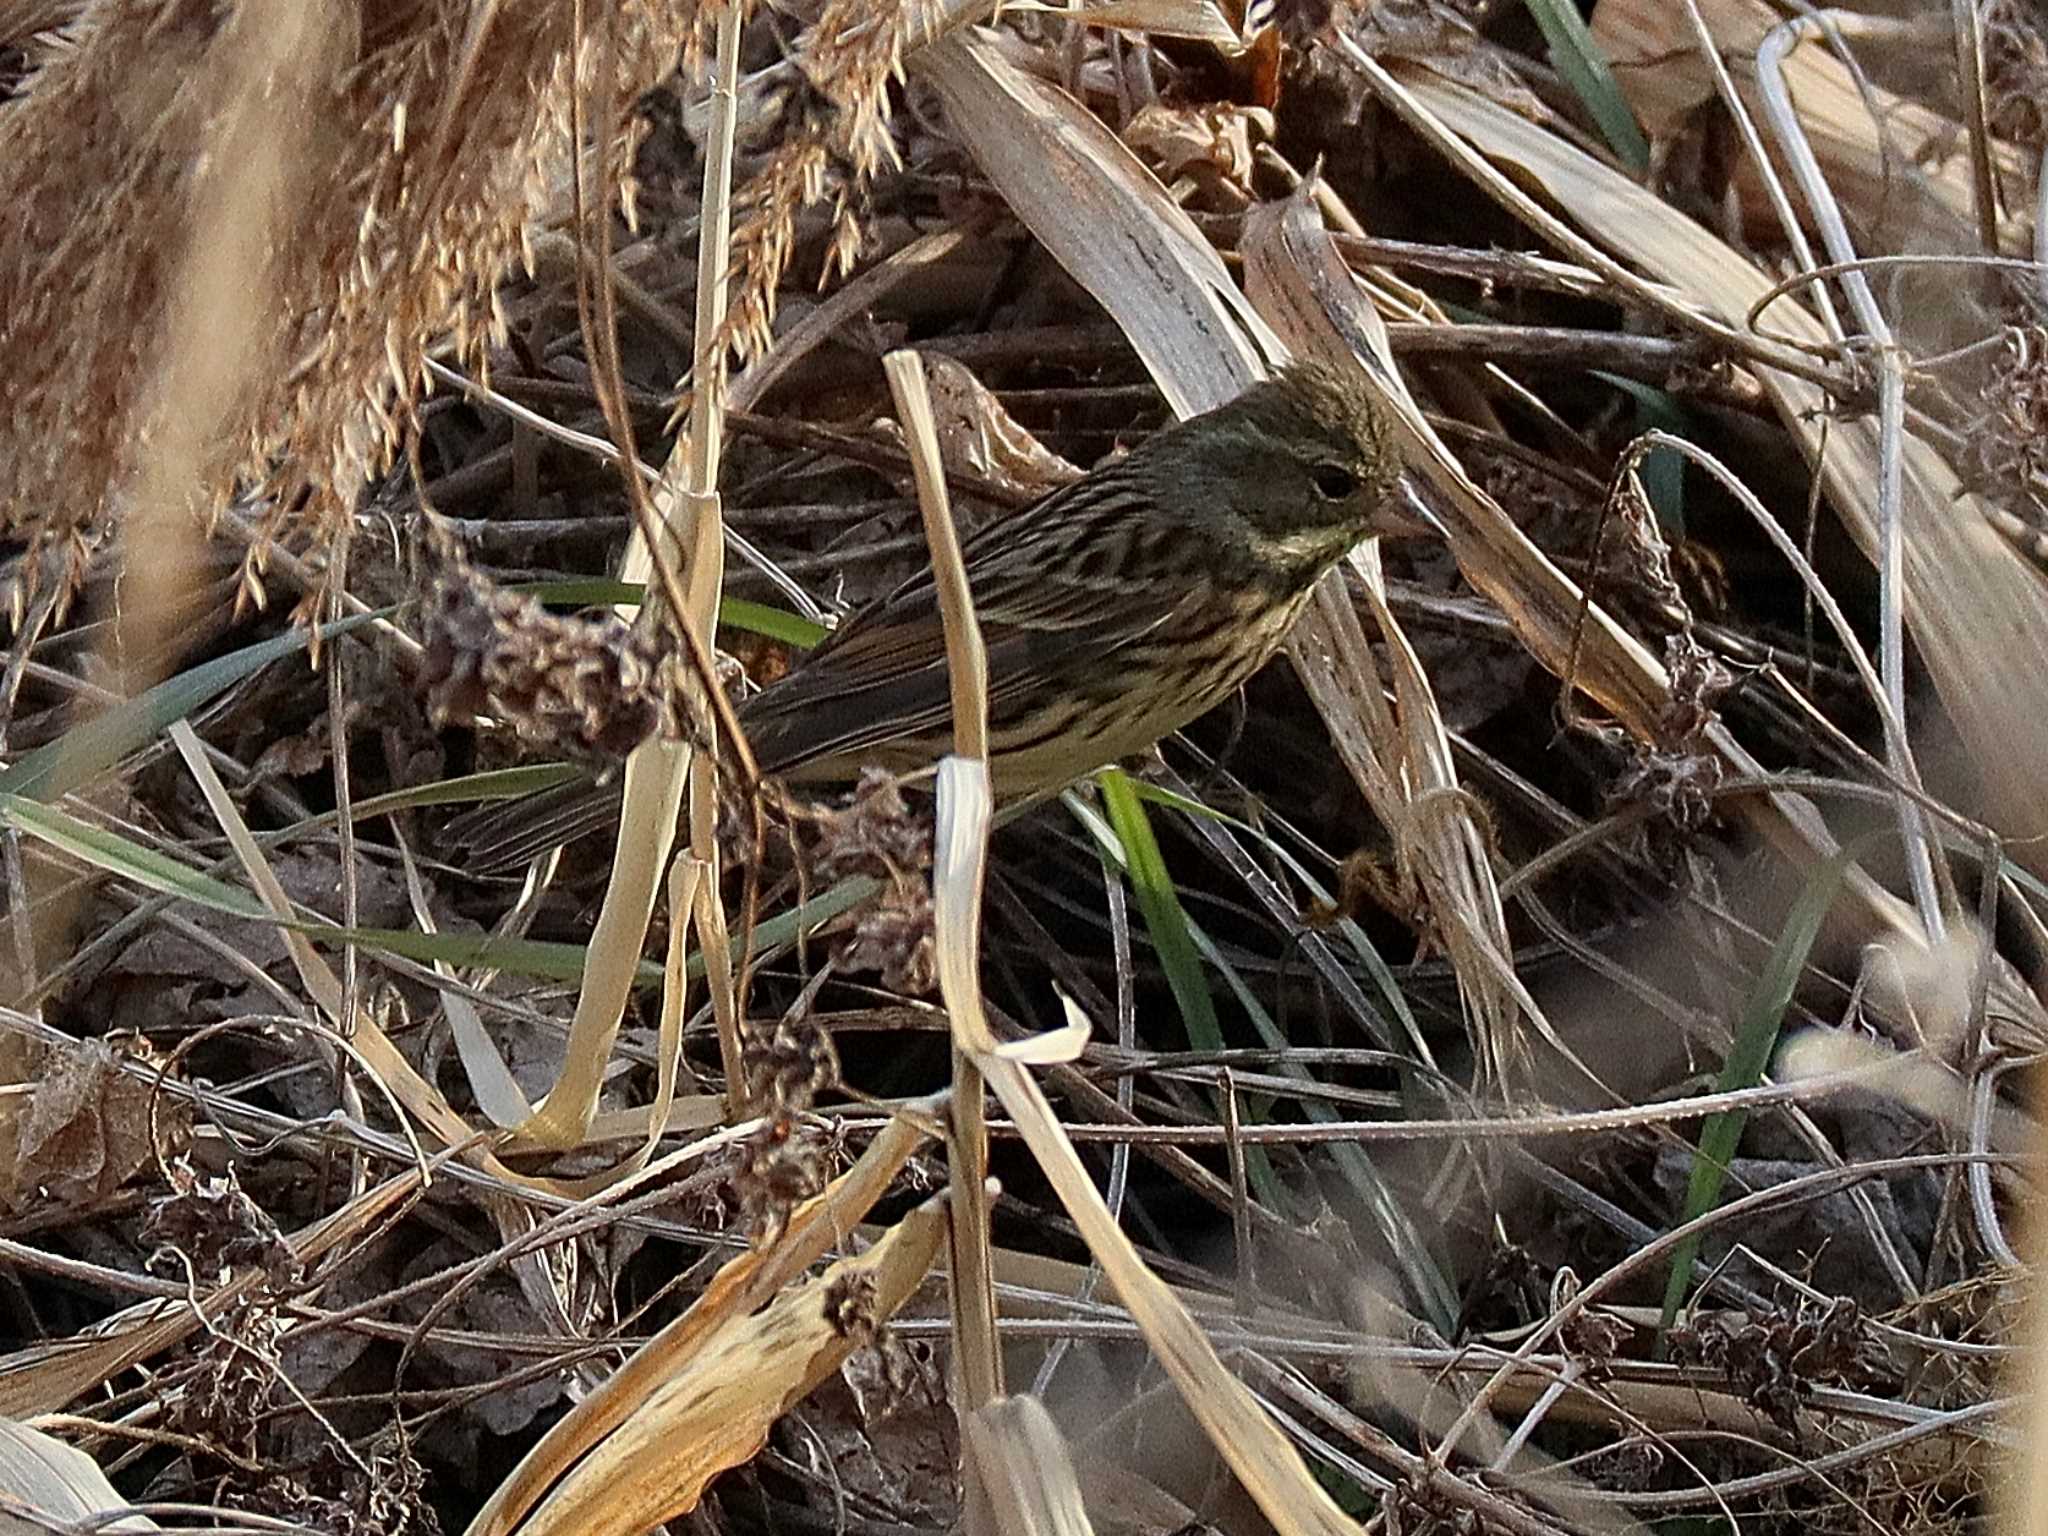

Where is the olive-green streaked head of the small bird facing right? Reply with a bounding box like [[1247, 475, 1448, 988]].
[[1147, 362, 1411, 580]]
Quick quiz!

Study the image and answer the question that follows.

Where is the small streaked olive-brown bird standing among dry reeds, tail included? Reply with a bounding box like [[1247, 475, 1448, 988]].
[[451, 362, 1415, 868]]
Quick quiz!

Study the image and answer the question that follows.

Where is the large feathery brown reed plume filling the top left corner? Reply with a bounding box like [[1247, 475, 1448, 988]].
[[0, 0, 696, 618]]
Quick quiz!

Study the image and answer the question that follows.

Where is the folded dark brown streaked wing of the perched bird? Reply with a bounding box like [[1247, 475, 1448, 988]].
[[741, 481, 1200, 772]]
